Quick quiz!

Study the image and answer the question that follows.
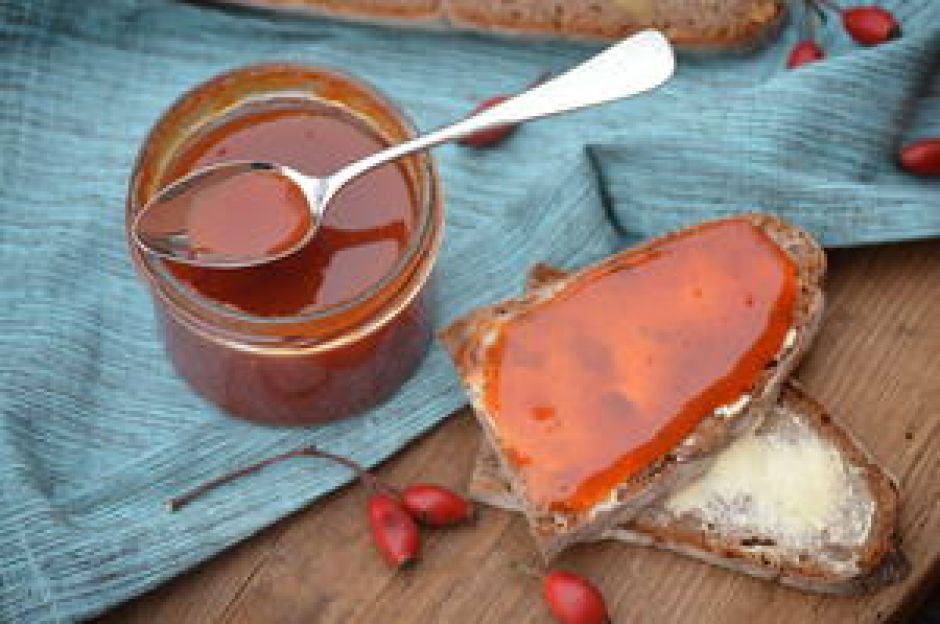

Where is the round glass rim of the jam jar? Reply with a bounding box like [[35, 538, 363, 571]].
[[127, 62, 439, 326]]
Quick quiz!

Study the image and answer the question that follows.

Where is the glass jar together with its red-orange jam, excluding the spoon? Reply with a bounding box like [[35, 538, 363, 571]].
[[127, 65, 443, 424]]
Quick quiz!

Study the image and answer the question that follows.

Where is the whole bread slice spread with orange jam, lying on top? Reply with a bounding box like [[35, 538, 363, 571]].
[[442, 215, 825, 558]]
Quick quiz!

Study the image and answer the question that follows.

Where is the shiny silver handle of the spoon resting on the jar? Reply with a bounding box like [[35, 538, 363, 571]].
[[327, 30, 675, 195]]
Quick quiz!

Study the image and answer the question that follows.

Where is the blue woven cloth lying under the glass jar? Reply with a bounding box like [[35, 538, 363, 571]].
[[0, 0, 940, 623]]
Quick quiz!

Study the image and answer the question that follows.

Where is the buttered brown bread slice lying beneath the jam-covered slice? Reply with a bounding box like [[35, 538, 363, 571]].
[[469, 380, 909, 594]]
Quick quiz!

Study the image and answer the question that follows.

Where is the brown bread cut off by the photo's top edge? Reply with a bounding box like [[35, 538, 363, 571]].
[[207, 0, 787, 50]]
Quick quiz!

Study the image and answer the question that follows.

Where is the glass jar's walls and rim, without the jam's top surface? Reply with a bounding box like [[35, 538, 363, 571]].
[[126, 64, 443, 425]]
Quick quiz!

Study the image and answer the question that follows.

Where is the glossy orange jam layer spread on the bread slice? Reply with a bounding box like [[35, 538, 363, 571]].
[[484, 220, 796, 512]]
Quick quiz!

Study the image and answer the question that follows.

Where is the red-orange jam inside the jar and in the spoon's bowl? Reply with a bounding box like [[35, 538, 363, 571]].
[[168, 109, 417, 316]]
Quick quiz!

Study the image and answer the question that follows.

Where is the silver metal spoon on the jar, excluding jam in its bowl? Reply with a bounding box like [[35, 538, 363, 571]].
[[132, 30, 675, 268]]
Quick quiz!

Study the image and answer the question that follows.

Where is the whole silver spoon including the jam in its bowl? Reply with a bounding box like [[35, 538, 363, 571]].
[[132, 30, 675, 269]]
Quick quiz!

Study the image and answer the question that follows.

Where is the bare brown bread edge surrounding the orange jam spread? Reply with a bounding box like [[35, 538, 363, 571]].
[[441, 215, 825, 559]]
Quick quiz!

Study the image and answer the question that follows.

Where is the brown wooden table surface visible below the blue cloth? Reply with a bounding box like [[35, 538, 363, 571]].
[[99, 241, 940, 624]]
